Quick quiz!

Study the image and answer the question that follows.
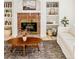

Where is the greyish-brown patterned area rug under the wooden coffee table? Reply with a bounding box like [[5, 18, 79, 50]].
[[4, 40, 66, 59]]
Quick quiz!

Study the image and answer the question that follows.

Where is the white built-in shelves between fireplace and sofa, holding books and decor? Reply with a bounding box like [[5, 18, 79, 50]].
[[46, 1, 59, 36]]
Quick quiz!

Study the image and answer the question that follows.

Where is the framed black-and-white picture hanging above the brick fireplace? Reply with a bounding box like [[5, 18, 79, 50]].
[[23, 0, 36, 10]]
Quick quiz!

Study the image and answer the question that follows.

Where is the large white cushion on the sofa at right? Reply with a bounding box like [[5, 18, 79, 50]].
[[61, 33, 75, 54]]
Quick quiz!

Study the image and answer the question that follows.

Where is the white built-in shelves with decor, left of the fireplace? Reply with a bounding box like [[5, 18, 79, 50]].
[[4, 1, 12, 35]]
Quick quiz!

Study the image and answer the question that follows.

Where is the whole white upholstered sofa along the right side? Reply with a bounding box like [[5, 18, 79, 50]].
[[57, 27, 75, 59]]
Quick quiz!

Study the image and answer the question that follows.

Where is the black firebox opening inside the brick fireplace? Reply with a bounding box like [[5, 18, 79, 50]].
[[21, 22, 37, 32]]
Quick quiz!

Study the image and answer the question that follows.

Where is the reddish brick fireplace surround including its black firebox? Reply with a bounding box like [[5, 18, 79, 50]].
[[17, 13, 40, 35]]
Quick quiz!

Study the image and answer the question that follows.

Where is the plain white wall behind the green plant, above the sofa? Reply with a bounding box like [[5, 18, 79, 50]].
[[59, 0, 75, 26]]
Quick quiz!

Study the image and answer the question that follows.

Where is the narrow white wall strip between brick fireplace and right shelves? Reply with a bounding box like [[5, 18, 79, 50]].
[[40, 0, 46, 37]]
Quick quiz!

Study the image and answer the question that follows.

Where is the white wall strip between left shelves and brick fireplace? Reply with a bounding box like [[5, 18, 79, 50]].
[[12, 0, 22, 36]]
